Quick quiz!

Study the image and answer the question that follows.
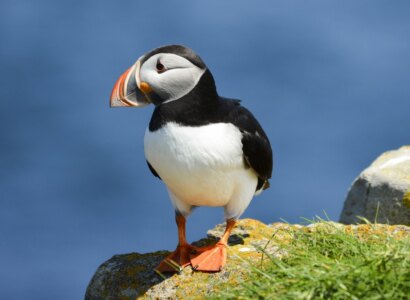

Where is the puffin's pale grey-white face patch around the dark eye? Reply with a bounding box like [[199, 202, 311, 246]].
[[137, 53, 206, 103]]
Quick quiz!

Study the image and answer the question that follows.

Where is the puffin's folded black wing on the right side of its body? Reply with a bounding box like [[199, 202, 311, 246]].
[[221, 99, 273, 190]]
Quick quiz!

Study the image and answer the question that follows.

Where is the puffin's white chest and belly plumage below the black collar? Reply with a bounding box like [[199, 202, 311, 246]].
[[144, 123, 249, 206]]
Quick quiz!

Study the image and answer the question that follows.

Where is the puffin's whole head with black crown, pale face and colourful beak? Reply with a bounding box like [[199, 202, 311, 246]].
[[110, 45, 207, 107]]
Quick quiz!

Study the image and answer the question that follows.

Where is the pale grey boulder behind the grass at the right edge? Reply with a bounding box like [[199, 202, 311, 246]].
[[340, 146, 410, 225]]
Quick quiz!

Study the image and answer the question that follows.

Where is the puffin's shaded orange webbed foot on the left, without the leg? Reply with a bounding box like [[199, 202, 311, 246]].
[[155, 244, 197, 273]]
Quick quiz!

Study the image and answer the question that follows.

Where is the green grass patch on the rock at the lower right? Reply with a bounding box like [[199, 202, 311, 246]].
[[212, 222, 410, 299]]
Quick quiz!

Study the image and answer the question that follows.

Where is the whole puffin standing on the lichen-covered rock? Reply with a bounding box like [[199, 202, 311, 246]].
[[110, 45, 273, 273]]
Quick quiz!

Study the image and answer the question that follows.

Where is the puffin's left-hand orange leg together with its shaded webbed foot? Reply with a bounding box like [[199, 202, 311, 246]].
[[155, 213, 197, 273]]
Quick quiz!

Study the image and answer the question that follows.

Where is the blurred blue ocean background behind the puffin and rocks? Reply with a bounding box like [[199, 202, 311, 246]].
[[0, 0, 410, 300]]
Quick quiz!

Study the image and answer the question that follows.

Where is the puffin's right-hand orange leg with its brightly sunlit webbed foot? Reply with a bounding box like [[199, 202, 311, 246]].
[[191, 219, 236, 272]]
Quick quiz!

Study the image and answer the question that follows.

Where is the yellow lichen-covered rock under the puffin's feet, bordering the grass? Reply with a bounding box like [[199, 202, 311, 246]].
[[85, 219, 410, 300]]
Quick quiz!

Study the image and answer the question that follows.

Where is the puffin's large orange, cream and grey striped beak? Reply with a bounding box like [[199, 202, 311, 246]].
[[110, 60, 151, 107]]
